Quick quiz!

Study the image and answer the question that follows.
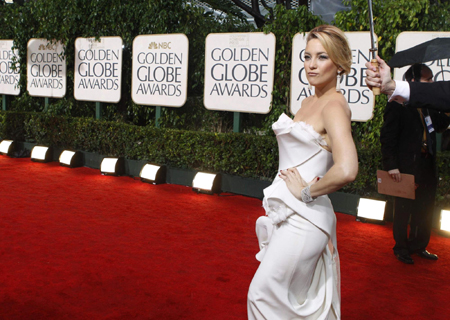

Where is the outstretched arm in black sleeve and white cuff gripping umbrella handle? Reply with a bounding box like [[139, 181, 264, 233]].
[[365, 56, 450, 112]]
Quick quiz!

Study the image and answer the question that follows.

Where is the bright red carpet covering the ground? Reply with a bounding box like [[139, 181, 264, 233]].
[[0, 156, 450, 320]]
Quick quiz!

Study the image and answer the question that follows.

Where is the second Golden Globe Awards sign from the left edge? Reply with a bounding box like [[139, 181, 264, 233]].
[[27, 39, 67, 98]]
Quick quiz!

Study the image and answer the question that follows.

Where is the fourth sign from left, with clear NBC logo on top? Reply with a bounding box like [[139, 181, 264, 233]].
[[131, 34, 189, 107]]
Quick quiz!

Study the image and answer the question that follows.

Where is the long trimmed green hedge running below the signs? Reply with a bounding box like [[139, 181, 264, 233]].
[[0, 111, 450, 206]]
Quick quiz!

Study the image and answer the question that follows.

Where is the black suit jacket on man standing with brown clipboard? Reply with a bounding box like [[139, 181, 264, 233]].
[[380, 102, 450, 176]]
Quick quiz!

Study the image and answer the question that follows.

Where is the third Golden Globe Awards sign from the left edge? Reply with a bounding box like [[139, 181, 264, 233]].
[[74, 37, 123, 103]]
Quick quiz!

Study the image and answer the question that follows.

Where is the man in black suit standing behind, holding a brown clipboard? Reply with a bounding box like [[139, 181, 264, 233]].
[[380, 64, 450, 264]]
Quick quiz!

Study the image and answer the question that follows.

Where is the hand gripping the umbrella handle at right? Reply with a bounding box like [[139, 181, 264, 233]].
[[366, 56, 395, 96]]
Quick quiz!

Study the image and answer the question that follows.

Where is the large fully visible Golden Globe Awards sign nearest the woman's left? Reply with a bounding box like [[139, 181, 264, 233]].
[[204, 32, 275, 113]]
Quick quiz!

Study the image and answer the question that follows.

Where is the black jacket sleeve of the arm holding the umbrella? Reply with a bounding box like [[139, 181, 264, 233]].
[[408, 81, 450, 112]]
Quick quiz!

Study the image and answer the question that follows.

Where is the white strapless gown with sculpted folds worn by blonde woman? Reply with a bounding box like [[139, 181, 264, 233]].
[[248, 114, 341, 320]]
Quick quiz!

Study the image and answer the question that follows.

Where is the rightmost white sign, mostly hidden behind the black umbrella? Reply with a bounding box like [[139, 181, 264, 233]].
[[394, 31, 450, 81]]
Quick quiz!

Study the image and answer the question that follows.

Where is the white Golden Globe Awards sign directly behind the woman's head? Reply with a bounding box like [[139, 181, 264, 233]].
[[290, 32, 375, 121]]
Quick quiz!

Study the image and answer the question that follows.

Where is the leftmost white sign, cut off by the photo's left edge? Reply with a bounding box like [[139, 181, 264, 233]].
[[0, 40, 20, 96]]
